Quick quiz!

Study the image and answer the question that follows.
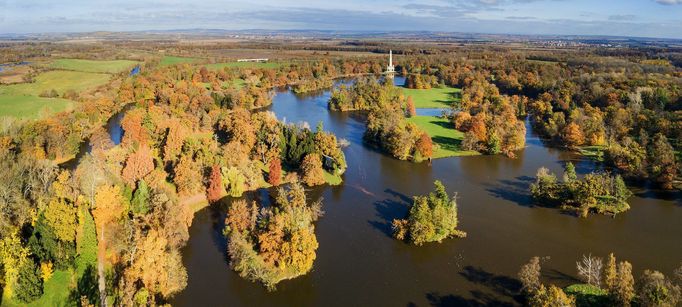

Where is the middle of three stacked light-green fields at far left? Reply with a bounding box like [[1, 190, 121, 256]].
[[0, 70, 111, 96]]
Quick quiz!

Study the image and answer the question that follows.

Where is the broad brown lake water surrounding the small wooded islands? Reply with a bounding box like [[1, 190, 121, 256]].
[[172, 80, 682, 306]]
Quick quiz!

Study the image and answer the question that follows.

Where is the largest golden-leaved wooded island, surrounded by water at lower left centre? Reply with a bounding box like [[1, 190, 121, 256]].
[[223, 182, 323, 290]]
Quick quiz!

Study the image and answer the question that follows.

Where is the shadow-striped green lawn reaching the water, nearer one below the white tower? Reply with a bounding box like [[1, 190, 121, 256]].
[[407, 116, 479, 159]]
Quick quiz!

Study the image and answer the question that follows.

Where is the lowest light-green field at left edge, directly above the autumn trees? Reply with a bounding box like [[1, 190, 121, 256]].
[[0, 95, 73, 119]]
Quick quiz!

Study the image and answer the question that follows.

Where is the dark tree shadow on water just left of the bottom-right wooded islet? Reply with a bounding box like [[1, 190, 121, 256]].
[[459, 265, 523, 303]]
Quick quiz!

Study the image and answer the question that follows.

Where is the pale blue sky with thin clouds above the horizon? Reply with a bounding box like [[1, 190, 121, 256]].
[[0, 0, 682, 39]]
